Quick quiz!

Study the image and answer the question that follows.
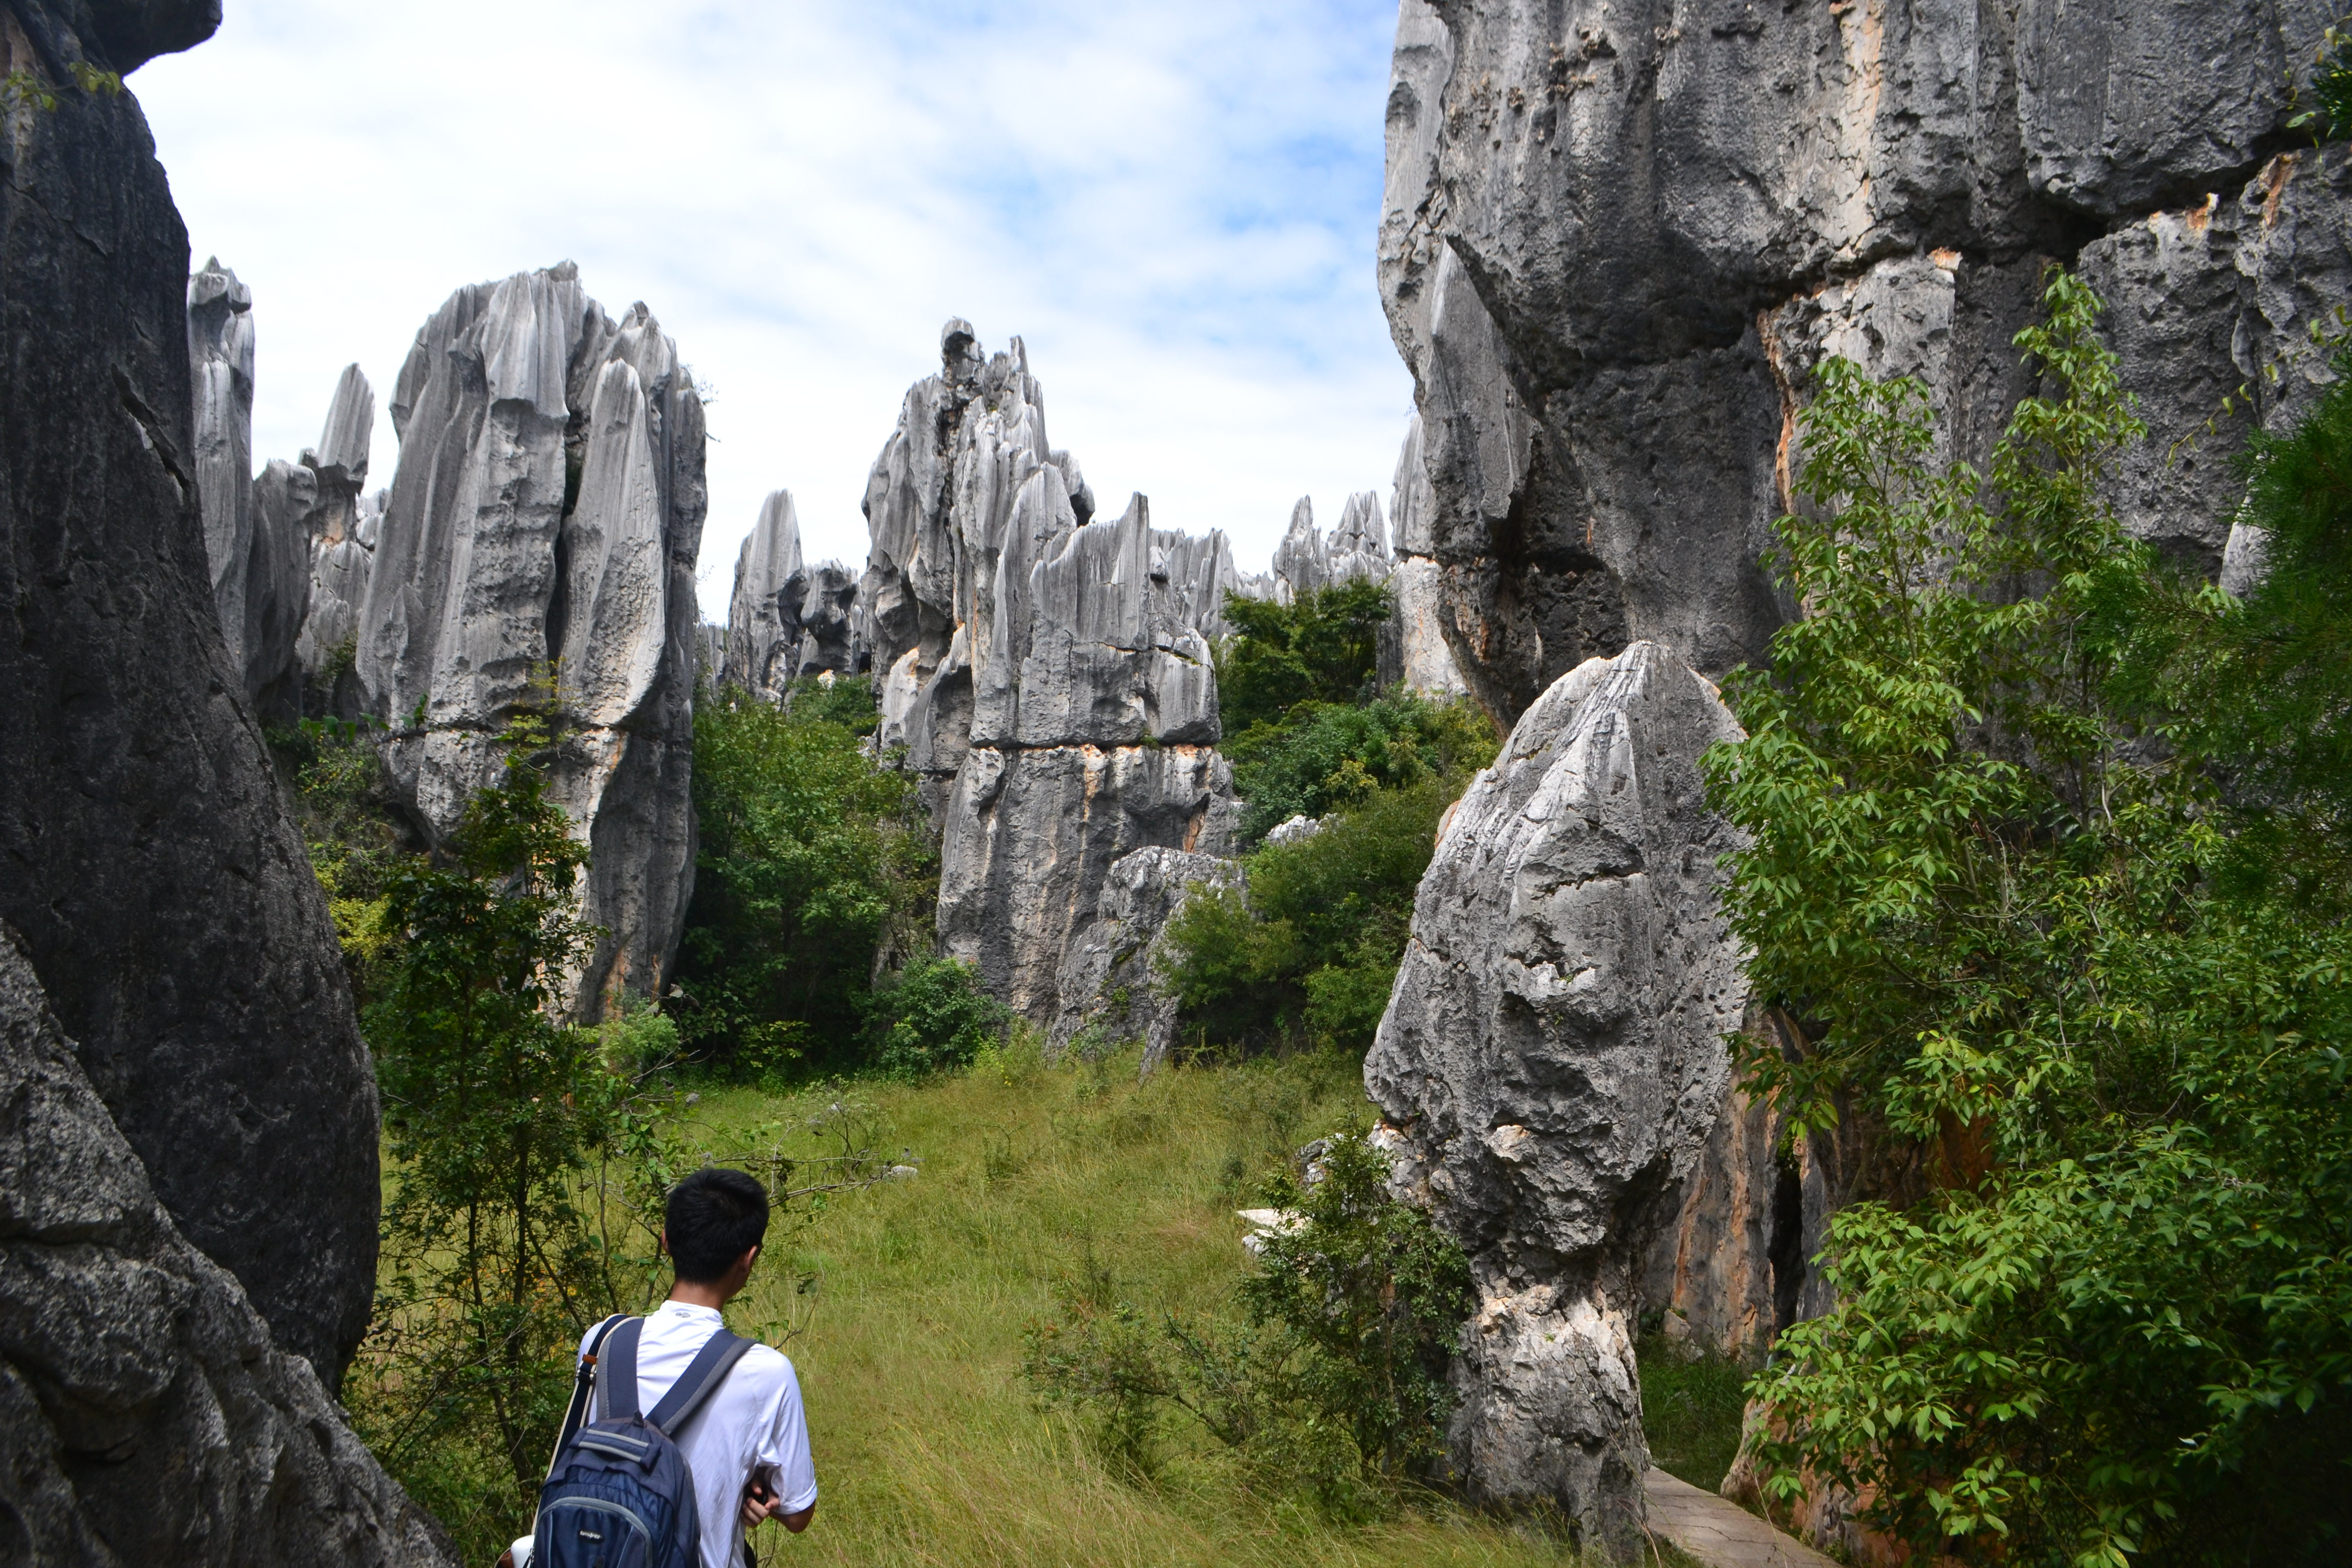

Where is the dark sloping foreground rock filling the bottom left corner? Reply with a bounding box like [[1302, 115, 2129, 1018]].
[[0, 924, 456, 1568]]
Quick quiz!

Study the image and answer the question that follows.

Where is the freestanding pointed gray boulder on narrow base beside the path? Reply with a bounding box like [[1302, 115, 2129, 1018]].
[[1364, 642, 1748, 1559]]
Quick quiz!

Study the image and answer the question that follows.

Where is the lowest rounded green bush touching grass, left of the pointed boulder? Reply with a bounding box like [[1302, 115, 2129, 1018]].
[[1160, 776, 1463, 1051]]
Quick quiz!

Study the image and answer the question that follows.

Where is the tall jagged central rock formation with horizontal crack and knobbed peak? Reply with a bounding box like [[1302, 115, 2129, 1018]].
[[861, 320, 1235, 1025]]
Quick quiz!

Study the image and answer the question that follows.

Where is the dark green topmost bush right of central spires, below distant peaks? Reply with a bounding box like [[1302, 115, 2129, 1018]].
[[1216, 578, 1390, 736]]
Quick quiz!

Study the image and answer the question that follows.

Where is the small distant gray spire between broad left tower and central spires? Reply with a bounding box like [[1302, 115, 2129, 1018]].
[[722, 489, 870, 703]]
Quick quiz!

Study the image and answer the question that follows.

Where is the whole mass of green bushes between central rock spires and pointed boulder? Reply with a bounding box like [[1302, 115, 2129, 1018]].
[[1162, 581, 1498, 1053]]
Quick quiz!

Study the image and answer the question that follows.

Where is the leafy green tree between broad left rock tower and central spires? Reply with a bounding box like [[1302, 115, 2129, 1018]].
[[677, 679, 936, 1076]]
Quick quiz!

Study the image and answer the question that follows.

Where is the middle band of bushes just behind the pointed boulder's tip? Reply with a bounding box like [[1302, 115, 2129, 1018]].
[[1226, 687, 1496, 844]]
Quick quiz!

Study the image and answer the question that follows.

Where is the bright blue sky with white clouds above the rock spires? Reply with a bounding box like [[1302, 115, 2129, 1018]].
[[129, 0, 1411, 618]]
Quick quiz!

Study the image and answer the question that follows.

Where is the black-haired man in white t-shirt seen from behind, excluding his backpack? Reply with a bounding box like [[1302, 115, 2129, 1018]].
[[510, 1166, 816, 1568]]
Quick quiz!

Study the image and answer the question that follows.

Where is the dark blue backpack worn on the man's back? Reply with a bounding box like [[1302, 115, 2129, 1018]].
[[531, 1316, 750, 1568]]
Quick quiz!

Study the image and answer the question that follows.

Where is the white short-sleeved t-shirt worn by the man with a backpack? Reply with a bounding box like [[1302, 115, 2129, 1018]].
[[581, 1303, 816, 1568]]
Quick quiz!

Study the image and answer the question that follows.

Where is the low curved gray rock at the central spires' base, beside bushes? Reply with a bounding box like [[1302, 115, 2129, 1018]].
[[1047, 844, 1242, 1072]]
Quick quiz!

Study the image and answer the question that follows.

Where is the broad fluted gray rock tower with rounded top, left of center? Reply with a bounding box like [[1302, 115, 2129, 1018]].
[[357, 261, 705, 1018]]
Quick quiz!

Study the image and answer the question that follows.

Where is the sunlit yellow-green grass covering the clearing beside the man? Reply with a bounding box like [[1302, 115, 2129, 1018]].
[[699, 1056, 1576, 1568]]
